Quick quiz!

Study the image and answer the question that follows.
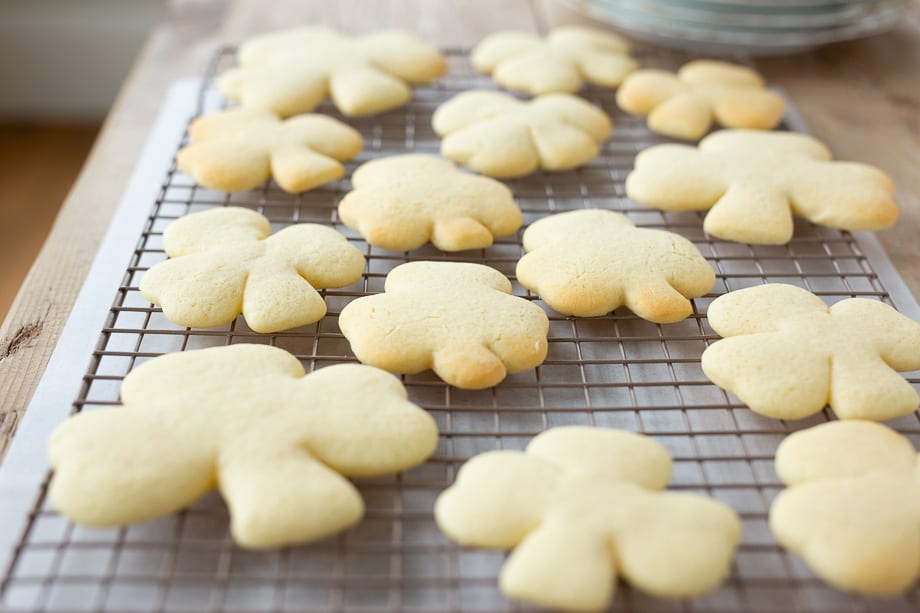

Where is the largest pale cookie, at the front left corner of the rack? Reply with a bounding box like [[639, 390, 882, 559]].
[[49, 345, 438, 549]]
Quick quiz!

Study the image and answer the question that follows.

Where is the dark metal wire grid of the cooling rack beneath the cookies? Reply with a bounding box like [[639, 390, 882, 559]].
[[0, 51, 920, 612]]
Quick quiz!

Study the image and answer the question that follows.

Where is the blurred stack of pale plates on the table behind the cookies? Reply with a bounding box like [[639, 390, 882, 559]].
[[569, 0, 910, 55]]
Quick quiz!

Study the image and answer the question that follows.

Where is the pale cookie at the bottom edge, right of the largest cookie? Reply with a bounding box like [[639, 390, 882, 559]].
[[434, 426, 741, 611]]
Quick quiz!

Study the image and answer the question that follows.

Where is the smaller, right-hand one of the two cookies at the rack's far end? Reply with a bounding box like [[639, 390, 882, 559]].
[[470, 26, 637, 96]]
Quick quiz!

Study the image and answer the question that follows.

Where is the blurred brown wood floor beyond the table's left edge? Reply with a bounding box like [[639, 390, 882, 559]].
[[0, 122, 99, 321]]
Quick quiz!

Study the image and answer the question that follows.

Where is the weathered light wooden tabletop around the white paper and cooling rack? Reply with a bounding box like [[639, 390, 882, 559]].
[[0, 0, 920, 457]]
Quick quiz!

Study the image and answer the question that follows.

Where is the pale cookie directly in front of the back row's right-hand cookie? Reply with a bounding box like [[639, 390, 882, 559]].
[[431, 90, 613, 178]]
